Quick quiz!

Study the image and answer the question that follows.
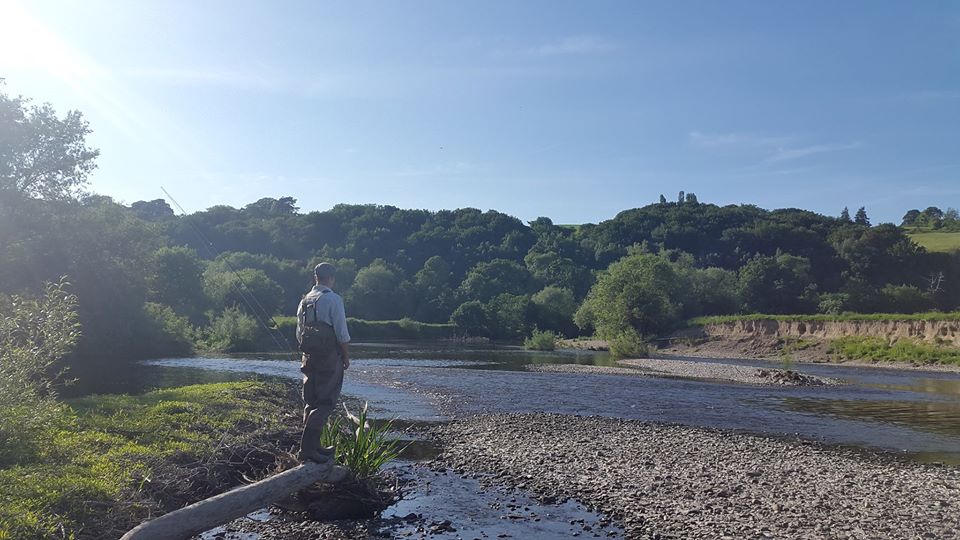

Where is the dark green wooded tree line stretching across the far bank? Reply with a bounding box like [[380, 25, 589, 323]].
[[0, 85, 960, 372]]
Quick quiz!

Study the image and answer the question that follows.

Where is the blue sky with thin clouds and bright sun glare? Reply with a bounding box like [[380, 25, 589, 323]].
[[0, 0, 960, 223]]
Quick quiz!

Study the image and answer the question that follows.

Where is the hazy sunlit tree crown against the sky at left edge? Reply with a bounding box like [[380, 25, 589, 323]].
[[0, 85, 99, 199]]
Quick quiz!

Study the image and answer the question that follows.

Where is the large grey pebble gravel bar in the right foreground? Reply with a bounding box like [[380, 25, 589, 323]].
[[436, 414, 960, 538]]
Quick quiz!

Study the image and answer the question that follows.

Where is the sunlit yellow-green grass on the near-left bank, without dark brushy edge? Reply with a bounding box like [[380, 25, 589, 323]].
[[0, 382, 289, 538]]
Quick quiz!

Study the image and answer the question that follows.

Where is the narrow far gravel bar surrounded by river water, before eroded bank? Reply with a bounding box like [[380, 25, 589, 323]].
[[620, 358, 840, 386]]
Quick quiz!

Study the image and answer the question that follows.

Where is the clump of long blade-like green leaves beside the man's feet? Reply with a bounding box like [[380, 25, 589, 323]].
[[320, 403, 403, 478]]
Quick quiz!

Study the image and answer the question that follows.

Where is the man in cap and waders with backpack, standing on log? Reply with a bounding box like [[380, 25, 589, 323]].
[[297, 262, 350, 465]]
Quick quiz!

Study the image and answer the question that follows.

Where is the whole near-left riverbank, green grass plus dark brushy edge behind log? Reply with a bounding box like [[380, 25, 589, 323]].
[[0, 382, 300, 540]]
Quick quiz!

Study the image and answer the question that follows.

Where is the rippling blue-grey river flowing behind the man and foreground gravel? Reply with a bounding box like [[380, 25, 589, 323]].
[[74, 343, 960, 463]]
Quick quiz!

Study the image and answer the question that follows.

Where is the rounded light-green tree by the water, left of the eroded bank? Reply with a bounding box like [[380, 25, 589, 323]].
[[574, 254, 691, 339]]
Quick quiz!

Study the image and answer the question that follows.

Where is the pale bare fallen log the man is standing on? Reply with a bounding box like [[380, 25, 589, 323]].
[[121, 462, 350, 540]]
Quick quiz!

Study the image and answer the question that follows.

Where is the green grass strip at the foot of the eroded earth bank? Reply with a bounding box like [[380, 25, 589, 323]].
[[828, 336, 960, 365]]
